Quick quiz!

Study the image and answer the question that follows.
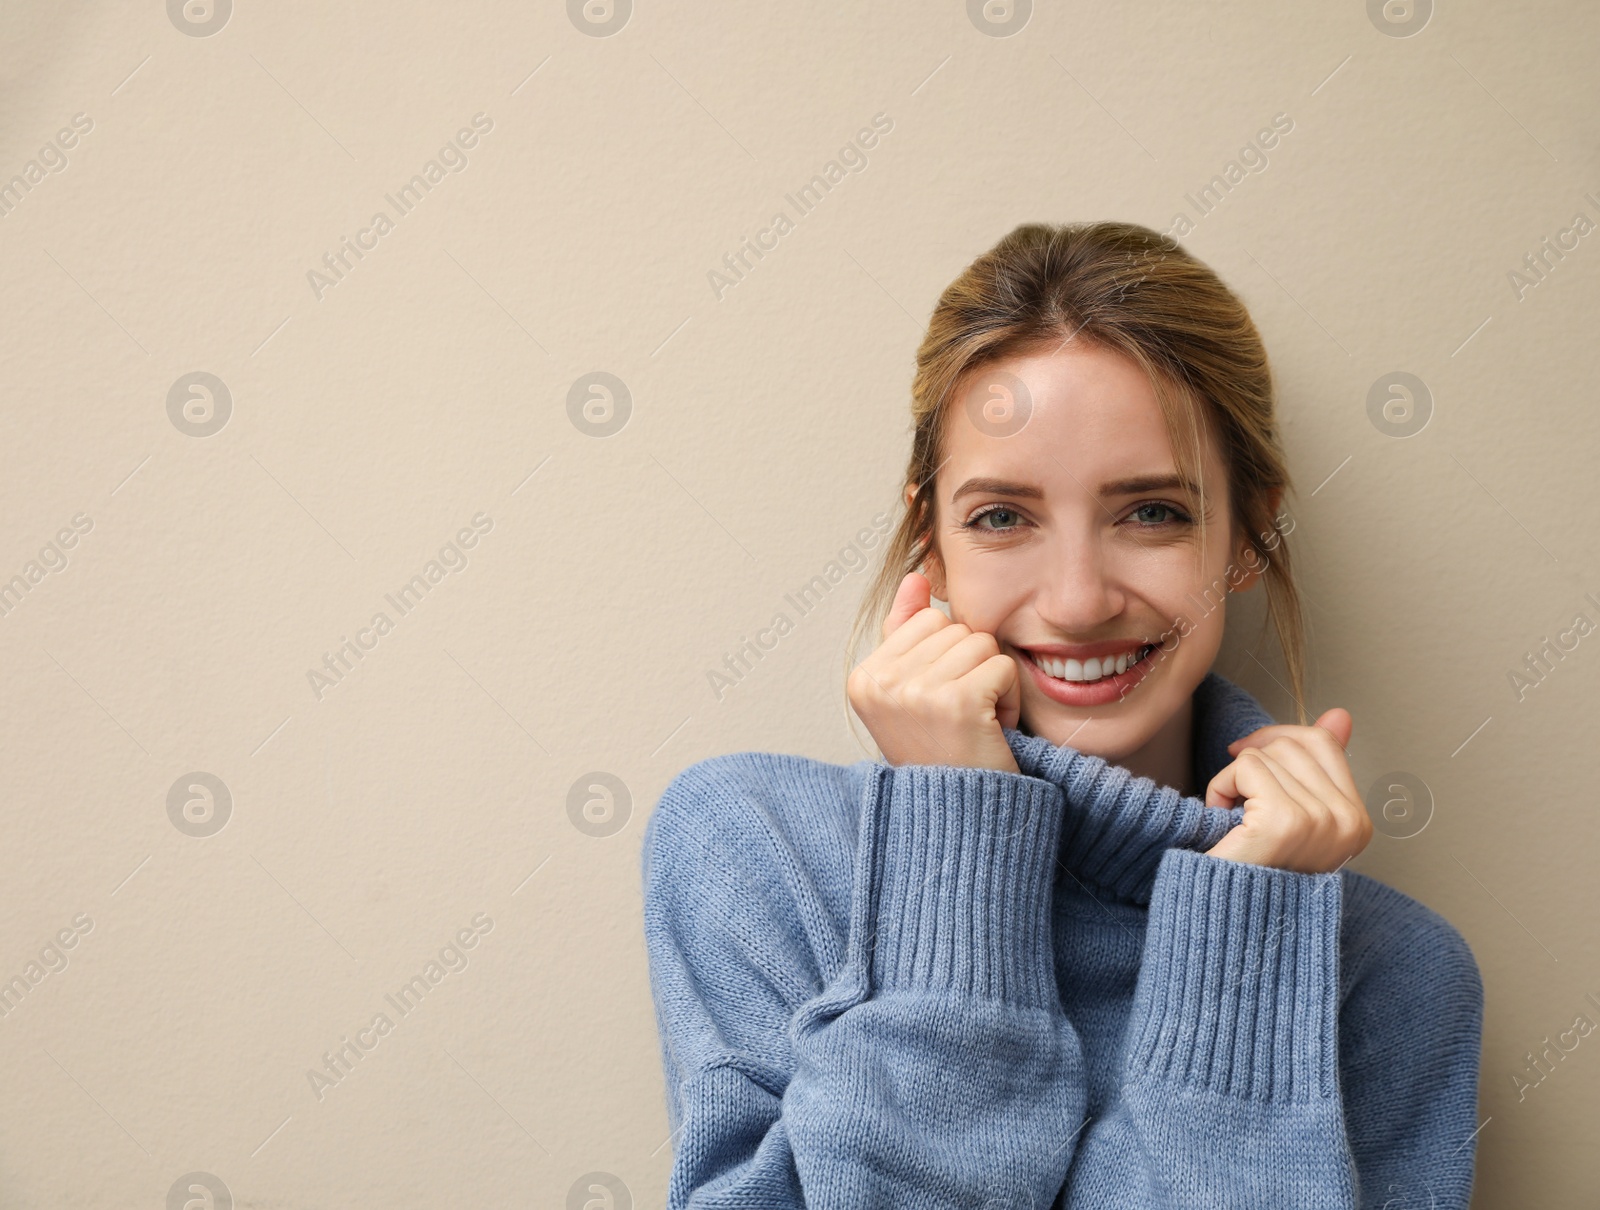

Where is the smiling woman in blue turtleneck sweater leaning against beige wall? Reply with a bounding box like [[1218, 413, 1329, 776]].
[[643, 222, 1483, 1210]]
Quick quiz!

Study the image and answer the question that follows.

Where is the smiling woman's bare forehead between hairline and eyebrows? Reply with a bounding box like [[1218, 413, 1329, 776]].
[[938, 341, 1222, 498]]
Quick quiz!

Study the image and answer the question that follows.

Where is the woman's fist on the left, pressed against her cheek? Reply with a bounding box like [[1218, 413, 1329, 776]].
[[846, 571, 1022, 773]]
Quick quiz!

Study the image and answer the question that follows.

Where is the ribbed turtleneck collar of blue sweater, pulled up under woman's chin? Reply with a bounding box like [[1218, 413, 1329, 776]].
[[1005, 672, 1275, 904]]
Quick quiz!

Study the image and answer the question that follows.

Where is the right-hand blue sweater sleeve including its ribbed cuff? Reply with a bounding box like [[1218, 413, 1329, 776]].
[[1067, 848, 1477, 1210]]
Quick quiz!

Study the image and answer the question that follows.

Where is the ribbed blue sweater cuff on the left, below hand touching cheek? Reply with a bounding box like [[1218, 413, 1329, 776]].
[[856, 765, 1062, 1007]]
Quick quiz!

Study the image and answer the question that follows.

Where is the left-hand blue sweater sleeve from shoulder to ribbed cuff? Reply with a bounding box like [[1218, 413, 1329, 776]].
[[645, 762, 1085, 1210]]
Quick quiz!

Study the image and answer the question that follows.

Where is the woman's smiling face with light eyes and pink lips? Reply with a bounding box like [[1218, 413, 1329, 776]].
[[926, 341, 1264, 763]]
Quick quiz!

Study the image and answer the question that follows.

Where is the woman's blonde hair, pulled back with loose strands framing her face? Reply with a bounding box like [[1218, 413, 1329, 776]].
[[846, 222, 1307, 738]]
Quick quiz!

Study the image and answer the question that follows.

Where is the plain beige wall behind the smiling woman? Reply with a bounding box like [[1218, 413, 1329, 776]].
[[0, 0, 1600, 1210]]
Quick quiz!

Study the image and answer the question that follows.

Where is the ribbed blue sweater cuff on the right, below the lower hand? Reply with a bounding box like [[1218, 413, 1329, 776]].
[[1128, 848, 1344, 1101]]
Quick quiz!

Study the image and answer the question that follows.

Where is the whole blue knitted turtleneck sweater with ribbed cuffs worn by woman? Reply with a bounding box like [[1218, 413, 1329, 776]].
[[642, 672, 1483, 1210]]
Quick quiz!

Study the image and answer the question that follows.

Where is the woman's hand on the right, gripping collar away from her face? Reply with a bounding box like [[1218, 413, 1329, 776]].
[[1205, 707, 1373, 874]]
